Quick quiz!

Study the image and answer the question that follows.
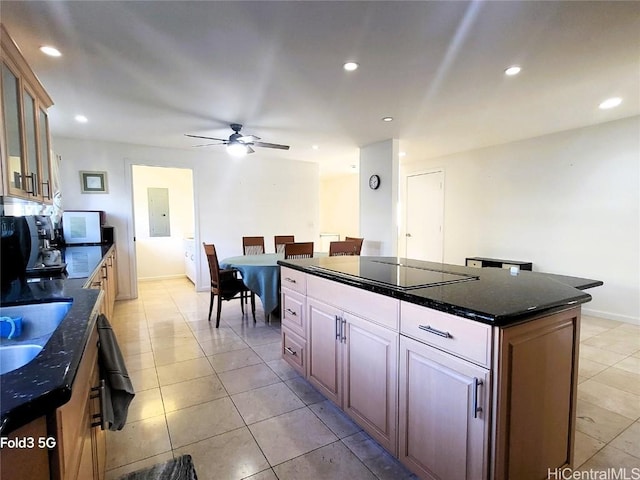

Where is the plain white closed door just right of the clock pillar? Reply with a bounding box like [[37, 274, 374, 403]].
[[405, 171, 444, 262]]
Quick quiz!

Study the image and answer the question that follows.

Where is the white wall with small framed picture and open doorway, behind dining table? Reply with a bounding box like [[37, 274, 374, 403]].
[[53, 137, 320, 298]]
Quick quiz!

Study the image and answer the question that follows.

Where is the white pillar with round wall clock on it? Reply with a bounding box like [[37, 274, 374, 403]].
[[360, 139, 399, 256]]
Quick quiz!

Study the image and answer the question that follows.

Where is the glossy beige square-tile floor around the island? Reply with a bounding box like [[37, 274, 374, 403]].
[[106, 278, 640, 480]]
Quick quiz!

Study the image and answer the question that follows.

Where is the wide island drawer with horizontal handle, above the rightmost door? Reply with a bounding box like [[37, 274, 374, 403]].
[[400, 302, 491, 367]]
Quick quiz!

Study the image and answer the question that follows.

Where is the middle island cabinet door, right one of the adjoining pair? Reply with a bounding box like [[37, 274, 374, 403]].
[[342, 313, 399, 455]]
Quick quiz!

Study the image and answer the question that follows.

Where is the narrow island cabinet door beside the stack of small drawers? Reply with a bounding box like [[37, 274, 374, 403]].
[[307, 298, 342, 407]]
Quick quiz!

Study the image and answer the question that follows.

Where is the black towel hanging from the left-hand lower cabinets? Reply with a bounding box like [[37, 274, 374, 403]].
[[98, 314, 135, 430]]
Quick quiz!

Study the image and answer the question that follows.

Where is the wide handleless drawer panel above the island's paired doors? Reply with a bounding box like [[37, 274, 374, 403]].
[[307, 275, 400, 332]]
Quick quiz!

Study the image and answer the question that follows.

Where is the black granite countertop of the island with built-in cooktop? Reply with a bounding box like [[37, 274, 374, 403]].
[[278, 256, 603, 326]]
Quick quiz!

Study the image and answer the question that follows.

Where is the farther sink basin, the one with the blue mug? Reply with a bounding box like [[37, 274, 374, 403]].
[[0, 300, 73, 342]]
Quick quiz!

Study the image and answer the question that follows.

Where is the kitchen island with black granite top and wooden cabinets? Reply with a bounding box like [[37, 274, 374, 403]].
[[279, 257, 602, 480]]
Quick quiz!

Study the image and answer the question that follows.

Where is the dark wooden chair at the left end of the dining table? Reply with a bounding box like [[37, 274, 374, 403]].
[[202, 242, 256, 328]]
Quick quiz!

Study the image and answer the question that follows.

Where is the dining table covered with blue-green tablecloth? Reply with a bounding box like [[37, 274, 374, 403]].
[[220, 252, 327, 317]]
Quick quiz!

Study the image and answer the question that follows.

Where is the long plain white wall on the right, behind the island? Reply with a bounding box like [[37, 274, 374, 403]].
[[402, 117, 640, 323]]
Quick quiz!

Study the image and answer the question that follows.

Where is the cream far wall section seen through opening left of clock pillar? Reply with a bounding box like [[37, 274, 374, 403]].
[[320, 173, 360, 240]]
